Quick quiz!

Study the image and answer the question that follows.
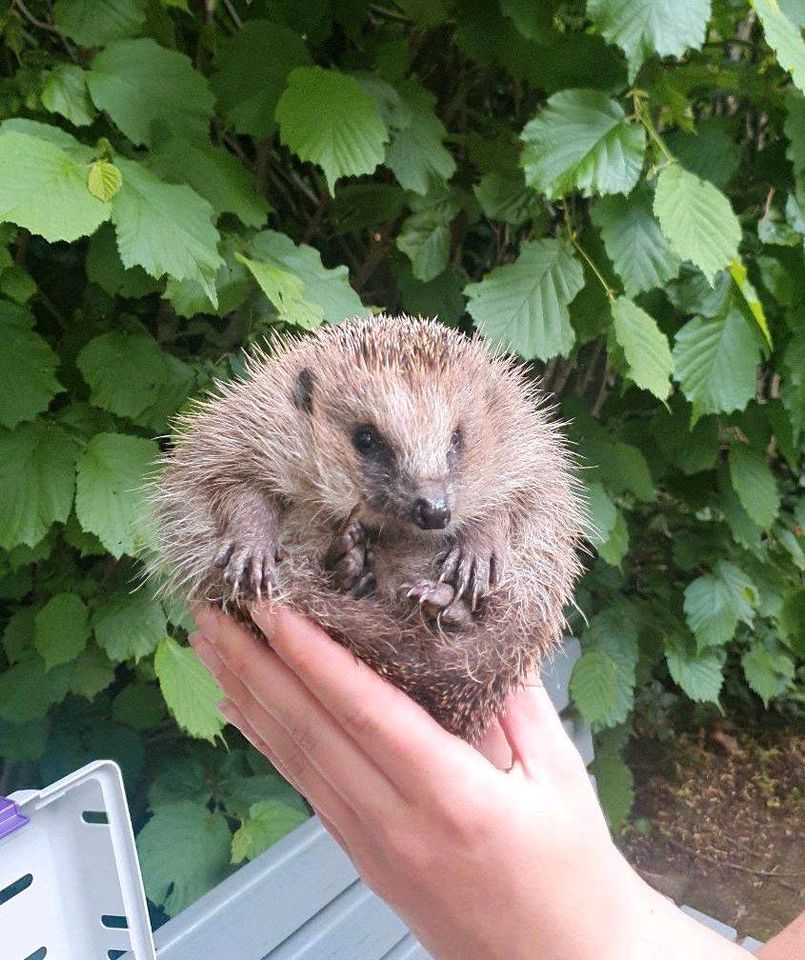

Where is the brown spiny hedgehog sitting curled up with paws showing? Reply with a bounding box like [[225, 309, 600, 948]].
[[149, 315, 584, 743]]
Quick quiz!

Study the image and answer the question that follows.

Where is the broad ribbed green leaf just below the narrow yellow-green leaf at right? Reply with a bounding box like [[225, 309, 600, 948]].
[[673, 306, 760, 420]]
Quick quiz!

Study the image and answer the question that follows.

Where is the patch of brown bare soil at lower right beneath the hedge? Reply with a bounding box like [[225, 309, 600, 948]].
[[619, 722, 805, 940]]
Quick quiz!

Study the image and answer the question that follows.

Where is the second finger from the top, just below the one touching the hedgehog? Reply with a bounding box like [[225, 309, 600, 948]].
[[191, 611, 400, 821]]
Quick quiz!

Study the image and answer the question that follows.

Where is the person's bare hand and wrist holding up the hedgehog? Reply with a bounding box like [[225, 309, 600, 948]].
[[191, 607, 768, 960]]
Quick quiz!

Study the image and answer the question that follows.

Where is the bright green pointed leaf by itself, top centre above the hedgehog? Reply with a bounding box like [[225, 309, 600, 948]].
[[276, 67, 389, 193]]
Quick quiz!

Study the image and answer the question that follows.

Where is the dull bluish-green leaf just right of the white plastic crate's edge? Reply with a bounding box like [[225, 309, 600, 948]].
[[137, 800, 231, 916]]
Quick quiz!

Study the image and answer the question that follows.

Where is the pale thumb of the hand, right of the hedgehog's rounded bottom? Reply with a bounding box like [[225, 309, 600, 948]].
[[500, 683, 586, 782]]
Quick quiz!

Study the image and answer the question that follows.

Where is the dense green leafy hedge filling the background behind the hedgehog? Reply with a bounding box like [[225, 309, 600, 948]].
[[0, 0, 805, 913]]
